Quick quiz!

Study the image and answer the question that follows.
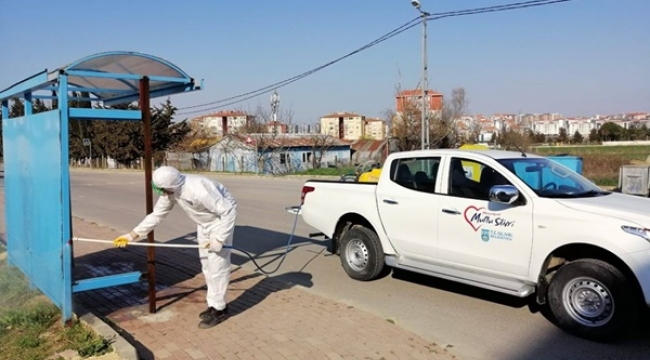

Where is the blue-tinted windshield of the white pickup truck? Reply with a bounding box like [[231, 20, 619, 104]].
[[498, 158, 611, 198]]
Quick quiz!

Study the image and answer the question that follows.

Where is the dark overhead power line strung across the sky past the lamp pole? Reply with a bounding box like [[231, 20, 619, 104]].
[[177, 0, 574, 115]]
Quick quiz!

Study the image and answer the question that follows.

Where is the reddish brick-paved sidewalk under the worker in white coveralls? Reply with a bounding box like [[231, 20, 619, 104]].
[[48, 218, 454, 360]]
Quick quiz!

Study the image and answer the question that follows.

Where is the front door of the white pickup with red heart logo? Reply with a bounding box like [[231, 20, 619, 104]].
[[438, 157, 533, 276]]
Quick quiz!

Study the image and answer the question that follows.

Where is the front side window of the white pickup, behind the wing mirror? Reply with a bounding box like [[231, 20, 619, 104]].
[[448, 158, 511, 201]]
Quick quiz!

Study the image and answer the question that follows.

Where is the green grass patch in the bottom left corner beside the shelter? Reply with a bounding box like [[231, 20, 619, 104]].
[[0, 245, 111, 360]]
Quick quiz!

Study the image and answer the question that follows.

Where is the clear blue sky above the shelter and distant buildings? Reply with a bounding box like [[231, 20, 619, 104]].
[[0, 0, 650, 124]]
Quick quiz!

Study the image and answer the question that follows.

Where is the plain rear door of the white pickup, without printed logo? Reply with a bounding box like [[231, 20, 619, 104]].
[[377, 157, 440, 258]]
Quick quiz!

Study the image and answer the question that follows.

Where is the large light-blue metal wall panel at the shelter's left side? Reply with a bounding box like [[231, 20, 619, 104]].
[[2, 110, 69, 306]]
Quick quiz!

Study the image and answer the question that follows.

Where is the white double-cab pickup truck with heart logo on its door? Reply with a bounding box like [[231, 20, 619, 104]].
[[300, 149, 650, 341]]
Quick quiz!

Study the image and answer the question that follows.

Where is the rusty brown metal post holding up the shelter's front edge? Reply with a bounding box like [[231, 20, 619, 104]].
[[140, 76, 156, 314]]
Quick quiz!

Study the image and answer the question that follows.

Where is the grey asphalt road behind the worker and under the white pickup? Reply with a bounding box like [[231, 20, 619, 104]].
[[5, 170, 650, 360]]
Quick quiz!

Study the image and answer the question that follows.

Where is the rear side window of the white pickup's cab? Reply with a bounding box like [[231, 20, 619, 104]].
[[390, 157, 440, 194]]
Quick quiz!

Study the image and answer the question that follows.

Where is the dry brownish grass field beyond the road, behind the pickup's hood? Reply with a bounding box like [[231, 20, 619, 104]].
[[532, 145, 650, 186]]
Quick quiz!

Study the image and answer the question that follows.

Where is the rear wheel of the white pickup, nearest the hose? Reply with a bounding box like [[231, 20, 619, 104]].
[[339, 225, 385, 281]]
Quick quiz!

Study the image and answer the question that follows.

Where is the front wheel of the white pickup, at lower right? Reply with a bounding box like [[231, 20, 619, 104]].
[[548, 259, 639, 342]]
